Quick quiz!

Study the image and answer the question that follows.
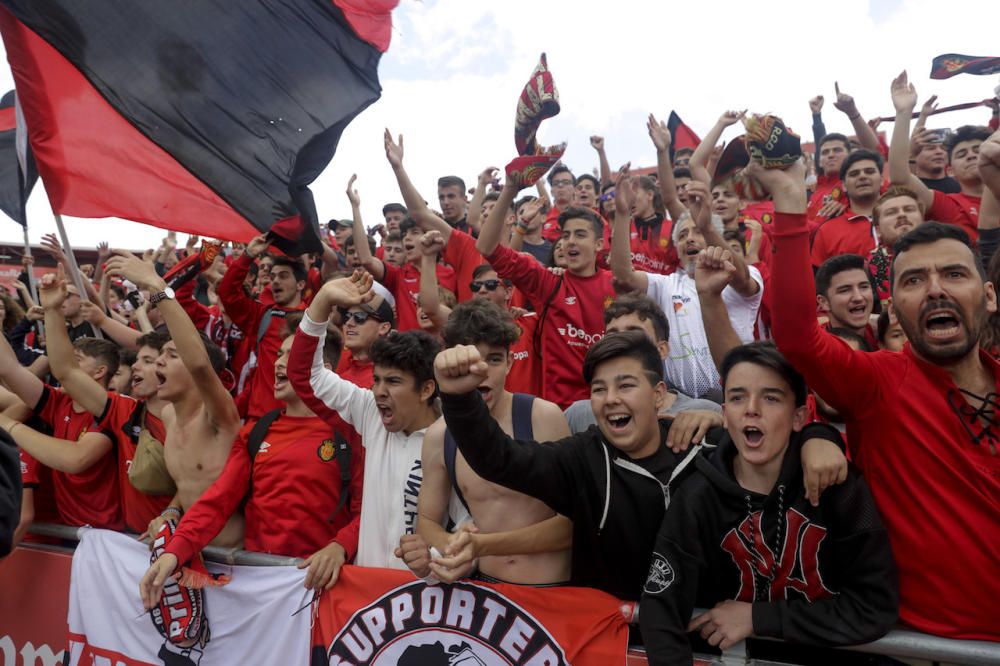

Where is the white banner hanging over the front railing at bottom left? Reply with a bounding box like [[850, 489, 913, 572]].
[[68, 530, 311, 666]]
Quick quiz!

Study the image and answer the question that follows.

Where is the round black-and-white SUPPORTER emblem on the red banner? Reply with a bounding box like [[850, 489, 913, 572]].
[[327, 581, 568, 666]]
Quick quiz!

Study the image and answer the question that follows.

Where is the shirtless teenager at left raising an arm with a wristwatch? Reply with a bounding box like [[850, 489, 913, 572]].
[[107, 251, 243, 547]]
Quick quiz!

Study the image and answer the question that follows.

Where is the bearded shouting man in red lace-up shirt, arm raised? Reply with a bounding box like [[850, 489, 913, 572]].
[[751, 153, 1000, 641]]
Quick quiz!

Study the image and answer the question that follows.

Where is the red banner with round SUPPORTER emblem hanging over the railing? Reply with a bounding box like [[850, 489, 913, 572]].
[[312, 566, 628, 666]]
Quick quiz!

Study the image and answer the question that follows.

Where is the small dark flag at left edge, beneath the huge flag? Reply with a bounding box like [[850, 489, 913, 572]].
[[0, 90, 38, 227]]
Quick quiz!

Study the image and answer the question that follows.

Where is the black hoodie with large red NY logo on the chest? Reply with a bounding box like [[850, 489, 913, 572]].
[[639, 433, 899, 665]]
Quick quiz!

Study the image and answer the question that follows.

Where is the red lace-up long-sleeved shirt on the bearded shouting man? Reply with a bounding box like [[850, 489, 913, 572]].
[[772, 213, 1000, 641]]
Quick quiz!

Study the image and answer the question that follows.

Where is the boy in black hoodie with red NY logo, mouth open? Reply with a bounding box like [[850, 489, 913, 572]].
[[639, 343, 899, 665]]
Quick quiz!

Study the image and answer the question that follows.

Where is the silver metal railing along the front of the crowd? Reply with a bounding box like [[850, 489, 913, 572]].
[[28, 523, 1000, 666]]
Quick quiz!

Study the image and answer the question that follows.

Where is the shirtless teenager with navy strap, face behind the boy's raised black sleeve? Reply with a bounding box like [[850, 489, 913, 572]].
[[414, 298, 573, 585]]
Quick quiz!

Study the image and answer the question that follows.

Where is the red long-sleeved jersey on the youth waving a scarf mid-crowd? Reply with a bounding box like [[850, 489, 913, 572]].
[[486, 245, 615, 409]]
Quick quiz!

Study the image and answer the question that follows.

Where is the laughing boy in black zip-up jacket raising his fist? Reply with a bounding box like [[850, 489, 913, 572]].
[[434, 331, 843, 600]]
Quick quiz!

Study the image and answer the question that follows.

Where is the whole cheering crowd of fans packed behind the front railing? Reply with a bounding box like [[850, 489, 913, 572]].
[[0, 73, 1000, 664]]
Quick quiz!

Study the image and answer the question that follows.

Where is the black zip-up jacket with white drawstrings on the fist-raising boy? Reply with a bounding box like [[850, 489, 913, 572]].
[[441, 392, 840, 601]]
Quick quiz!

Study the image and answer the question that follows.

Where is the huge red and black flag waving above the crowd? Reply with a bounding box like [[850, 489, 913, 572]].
[[0, 0, 398, 252]]
